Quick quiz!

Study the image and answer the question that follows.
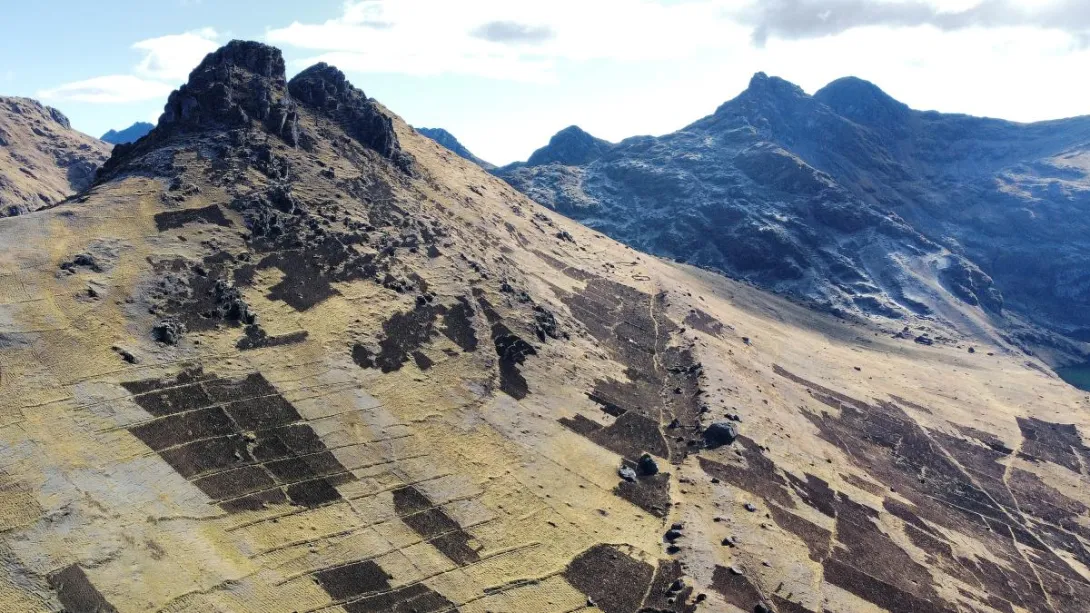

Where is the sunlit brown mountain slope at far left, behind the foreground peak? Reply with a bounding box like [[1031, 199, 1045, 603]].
[[0, 96, 110, 217]]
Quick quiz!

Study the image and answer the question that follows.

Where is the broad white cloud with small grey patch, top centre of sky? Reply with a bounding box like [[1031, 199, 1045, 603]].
[[266, 0, 748, 81]]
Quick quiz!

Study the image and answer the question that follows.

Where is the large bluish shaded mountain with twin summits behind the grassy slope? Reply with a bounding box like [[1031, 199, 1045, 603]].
[[497, 73, 1090, 352]]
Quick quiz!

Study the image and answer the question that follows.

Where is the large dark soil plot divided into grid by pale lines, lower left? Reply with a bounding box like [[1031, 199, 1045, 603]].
[[123, 369, 352, 513]]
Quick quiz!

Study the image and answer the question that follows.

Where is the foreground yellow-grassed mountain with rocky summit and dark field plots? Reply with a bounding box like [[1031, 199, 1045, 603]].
[[0, 41, 1090, 613]]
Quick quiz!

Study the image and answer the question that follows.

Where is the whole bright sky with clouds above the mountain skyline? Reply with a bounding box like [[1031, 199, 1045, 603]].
[[6, 0, 1090, 164]]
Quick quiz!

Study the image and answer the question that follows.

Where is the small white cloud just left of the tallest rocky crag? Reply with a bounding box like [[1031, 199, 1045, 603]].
[[37, 27, 219, 104]]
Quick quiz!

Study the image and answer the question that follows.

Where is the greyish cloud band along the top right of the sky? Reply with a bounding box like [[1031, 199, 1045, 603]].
[[738, 0, 1090, 46]]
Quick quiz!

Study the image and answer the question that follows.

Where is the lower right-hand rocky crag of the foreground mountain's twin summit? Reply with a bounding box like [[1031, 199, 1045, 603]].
[[288, 62, 413, 171]]
